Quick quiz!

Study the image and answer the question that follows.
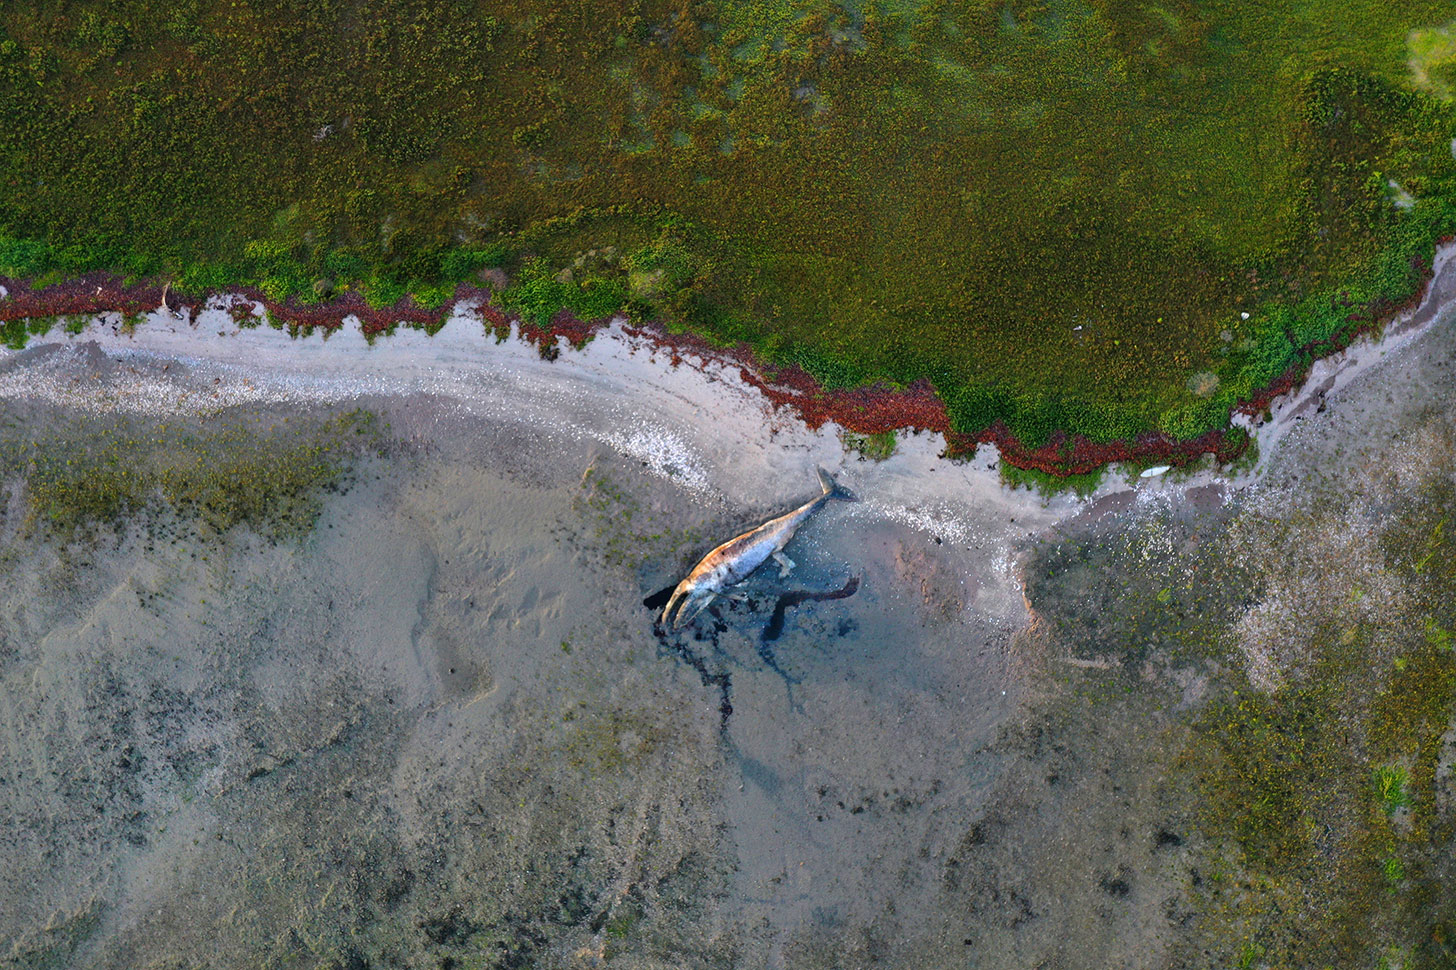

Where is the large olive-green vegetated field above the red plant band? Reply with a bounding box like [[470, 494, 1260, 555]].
[[0, 0, 1456, 444]]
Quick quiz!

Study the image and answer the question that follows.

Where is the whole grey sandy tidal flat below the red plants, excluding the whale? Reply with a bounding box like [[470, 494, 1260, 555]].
[[0, 284, 1456, 970]]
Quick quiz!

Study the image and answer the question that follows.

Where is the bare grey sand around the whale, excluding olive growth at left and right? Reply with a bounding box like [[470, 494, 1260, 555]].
[[0, 246, 1453, 970]]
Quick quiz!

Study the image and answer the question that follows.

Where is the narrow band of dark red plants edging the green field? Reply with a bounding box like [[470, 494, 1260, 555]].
[[0, 239, 1456, 478]]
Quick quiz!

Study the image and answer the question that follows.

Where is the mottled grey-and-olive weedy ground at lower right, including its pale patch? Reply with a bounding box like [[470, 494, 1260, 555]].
[[1007, 428, 1456, 969]]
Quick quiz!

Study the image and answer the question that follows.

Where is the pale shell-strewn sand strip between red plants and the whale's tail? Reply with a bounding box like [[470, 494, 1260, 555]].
[[0, 281, 1094, 628]]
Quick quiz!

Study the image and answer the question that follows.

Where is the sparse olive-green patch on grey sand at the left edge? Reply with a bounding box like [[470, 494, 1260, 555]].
[[0, 411, 380, 539]]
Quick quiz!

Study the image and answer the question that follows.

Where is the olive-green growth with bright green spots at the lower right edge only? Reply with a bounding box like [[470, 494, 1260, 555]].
[[1185, 480, 1456, 967]]
